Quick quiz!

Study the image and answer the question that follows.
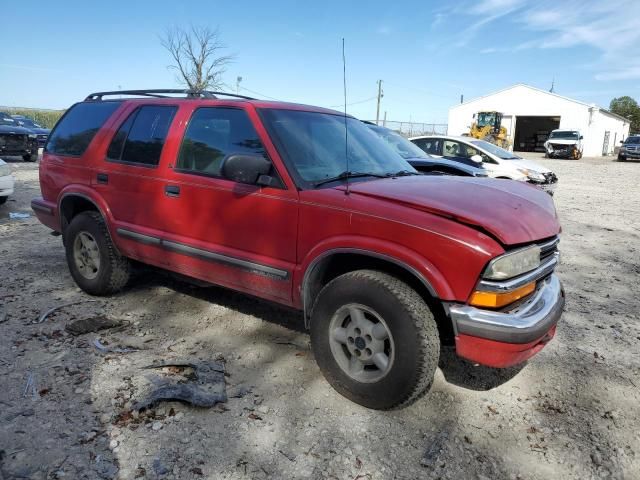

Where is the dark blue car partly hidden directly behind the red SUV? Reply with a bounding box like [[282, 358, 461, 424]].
[[363, 122, 488, 177]]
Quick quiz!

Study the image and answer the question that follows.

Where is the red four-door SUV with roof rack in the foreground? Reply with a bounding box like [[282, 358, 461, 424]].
[[32, 90, 564, 409]]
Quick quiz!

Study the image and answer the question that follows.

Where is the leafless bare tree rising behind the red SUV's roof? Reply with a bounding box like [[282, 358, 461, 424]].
[[160, 25, 233, 92]]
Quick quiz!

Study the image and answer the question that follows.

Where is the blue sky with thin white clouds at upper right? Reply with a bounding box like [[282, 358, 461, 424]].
[[0, 0, 640, 123]]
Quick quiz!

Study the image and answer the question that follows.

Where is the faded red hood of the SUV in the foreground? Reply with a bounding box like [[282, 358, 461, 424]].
[[342, 176, 560, 245]]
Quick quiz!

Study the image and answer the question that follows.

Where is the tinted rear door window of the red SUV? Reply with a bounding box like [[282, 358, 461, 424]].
[[107, 105, 177, 167]]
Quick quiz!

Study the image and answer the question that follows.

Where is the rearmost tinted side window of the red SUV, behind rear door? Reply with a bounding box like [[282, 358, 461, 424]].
[[45, 102, 120, 157]]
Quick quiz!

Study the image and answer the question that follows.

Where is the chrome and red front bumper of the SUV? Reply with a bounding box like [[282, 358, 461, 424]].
[[449, 275, 565, 367]]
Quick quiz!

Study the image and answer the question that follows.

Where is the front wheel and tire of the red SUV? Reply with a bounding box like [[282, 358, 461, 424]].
[[311, 270, 440, 410]]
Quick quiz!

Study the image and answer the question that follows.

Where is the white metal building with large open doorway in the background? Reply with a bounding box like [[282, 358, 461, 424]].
[[448, 84, 630, 156]]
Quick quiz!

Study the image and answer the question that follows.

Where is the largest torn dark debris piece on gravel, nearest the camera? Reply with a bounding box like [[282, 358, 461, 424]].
[[133, 361, 227, 410]]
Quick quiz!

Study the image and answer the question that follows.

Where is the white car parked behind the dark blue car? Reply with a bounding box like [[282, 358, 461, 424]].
[[409, 135, 558, 195]]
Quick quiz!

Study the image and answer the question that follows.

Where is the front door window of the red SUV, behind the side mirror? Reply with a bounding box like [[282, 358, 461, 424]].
[[176, 107, 266, 176]]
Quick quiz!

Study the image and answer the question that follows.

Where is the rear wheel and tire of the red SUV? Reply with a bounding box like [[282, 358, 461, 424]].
[[63, 212, 131, 296]]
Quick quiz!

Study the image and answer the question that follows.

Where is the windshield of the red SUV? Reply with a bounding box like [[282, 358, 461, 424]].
[[261, 109, 416, 184]]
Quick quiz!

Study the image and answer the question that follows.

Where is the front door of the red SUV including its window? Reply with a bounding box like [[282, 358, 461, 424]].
[[162, 107, 298, 301]]
